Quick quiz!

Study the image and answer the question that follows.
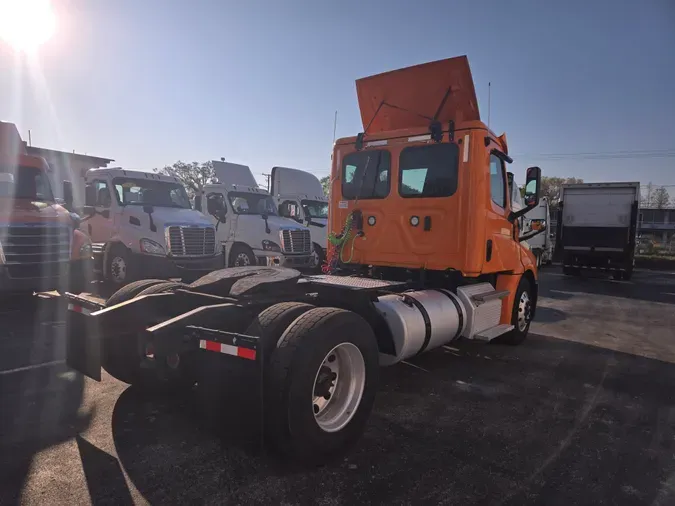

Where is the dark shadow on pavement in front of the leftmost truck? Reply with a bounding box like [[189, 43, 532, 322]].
[[0, 305, 91, 504]]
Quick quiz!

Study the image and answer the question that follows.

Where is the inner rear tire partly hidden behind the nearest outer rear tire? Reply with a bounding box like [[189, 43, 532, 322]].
[[244, 302, 315, 370]]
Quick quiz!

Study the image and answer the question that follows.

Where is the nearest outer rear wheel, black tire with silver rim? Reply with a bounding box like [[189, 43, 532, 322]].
[[265, 307, 379, 464]]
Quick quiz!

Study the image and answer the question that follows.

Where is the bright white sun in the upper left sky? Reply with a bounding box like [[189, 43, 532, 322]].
[[0, 0, 56, 53]]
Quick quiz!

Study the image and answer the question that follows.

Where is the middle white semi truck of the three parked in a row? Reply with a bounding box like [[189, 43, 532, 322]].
[[195, 161, 312, 269]]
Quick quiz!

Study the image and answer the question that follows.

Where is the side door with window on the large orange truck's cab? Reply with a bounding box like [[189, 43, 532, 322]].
[[483, 153, 520, 273]]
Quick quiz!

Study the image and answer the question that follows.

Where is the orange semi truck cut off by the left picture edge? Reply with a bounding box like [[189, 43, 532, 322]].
[[0, 122, 92, 295]]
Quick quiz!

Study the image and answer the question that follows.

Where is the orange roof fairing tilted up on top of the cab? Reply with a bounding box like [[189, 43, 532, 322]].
[[356, 56, 480, 134]]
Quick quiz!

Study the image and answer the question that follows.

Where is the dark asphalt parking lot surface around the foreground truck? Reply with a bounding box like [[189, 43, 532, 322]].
[[0, 267, 675, 505]]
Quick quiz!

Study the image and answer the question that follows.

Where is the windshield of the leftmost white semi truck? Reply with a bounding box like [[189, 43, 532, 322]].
[[113, 177, 192, 209]]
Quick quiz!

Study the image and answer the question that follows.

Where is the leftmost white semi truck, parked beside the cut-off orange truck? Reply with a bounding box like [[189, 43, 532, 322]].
[[78, 168, 223, 287]]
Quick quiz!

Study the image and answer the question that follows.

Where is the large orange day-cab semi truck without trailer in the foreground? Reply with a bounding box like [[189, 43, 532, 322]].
[[51, 57, 541, 462]]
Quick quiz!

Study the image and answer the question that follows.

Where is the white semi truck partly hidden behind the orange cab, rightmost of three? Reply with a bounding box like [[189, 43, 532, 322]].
[[271, 167, 328, 267]]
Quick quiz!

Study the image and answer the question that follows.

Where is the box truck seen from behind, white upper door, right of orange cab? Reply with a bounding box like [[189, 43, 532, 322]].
[[554, 182, 640, 280]]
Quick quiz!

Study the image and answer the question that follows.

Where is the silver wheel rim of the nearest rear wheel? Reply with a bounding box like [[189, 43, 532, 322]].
[[312, 343, 366, 432]]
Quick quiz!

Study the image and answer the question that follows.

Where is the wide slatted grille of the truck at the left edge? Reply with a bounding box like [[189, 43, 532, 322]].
[[0, 224, 71, 278]]
